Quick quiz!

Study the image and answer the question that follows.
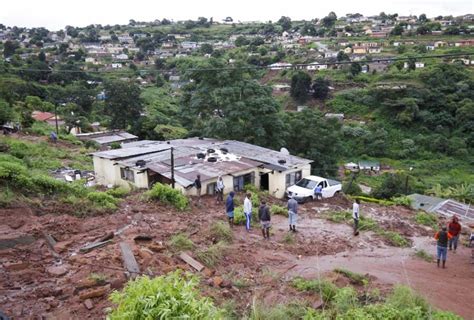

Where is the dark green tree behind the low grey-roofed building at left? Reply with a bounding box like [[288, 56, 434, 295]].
[[104, 80, 143, 129]]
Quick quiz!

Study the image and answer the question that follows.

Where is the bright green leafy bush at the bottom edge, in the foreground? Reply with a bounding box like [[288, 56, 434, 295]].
[[108, 270, 222, 320]]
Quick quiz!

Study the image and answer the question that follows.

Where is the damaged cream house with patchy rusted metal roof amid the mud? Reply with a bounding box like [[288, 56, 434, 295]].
[[92, 138, 312, 198]]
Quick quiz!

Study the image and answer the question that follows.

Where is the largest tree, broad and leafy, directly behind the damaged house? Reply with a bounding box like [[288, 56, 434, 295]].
[[180, 58, 285, 148]]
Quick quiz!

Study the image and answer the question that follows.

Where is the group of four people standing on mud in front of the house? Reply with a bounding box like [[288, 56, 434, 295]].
[[225, 191, 298, 239]]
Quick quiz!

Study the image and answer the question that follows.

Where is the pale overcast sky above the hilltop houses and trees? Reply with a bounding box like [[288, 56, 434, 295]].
[[0, 0, 474, 30]]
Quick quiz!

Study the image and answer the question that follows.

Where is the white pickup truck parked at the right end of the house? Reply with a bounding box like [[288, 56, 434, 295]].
[[286, 176, 342, 202]]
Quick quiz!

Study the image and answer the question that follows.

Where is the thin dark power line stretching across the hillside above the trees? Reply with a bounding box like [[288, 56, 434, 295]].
[[0, 52, 474, 74]]
